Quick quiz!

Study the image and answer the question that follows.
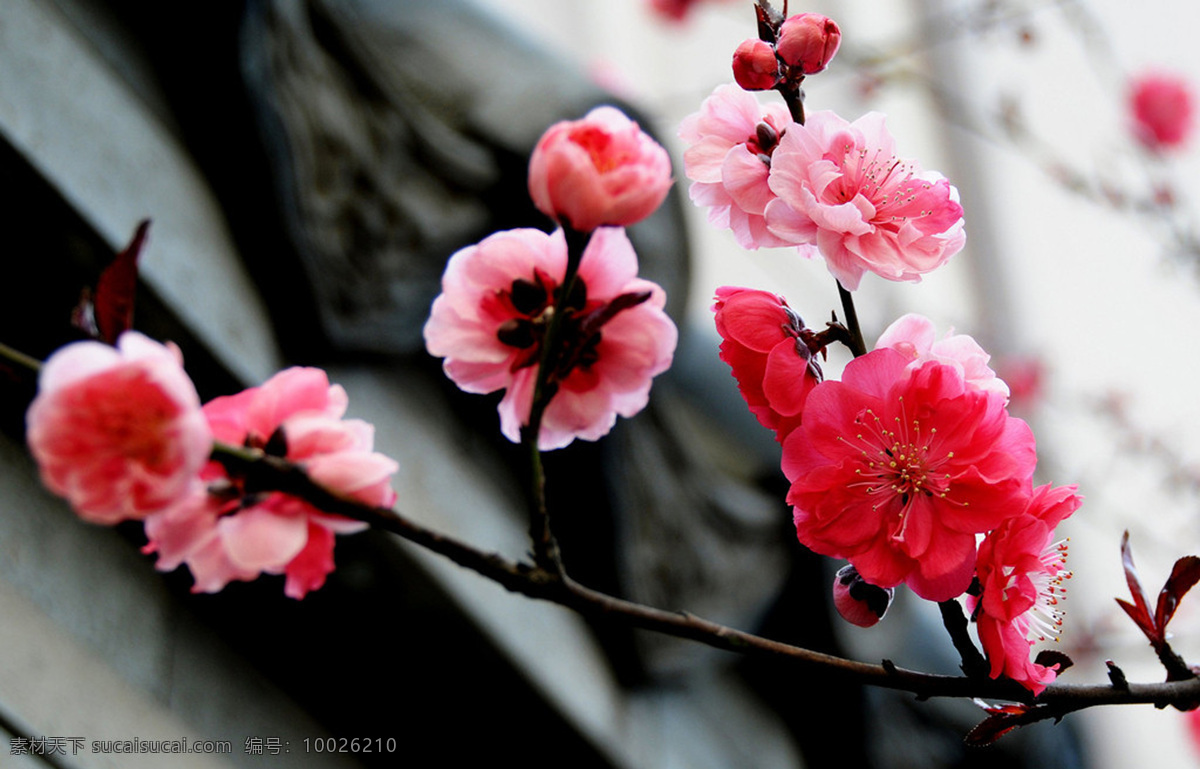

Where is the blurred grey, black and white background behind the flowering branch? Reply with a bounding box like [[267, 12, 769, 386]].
[[0, 0, 1200, 769]]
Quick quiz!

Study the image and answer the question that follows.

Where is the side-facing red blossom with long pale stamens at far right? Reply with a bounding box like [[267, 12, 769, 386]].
[[971, 485, 1082, 695]]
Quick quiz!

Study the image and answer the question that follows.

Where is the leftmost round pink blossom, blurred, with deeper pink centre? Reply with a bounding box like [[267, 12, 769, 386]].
[[25, 331, 212, 524]]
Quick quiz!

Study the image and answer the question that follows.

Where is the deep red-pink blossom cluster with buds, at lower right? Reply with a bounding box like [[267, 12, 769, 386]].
[[714, 287, 1080, 692]]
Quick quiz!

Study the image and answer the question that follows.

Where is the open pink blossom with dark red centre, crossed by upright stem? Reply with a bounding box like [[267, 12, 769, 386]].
[[425, 227, 677, 450]]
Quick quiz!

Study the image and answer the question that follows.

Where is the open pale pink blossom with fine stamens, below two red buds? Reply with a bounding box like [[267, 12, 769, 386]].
[[766, 112, 966, 290]]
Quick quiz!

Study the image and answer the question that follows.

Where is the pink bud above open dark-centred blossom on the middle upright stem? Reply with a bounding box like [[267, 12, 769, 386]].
[[425, 107, 677, 450]]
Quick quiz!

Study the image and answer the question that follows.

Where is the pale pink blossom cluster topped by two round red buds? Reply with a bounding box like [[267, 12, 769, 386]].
[[679, 13, 966, 290]]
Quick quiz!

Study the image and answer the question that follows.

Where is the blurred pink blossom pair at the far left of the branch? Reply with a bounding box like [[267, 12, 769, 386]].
[[26, 331, 397, 599]]
